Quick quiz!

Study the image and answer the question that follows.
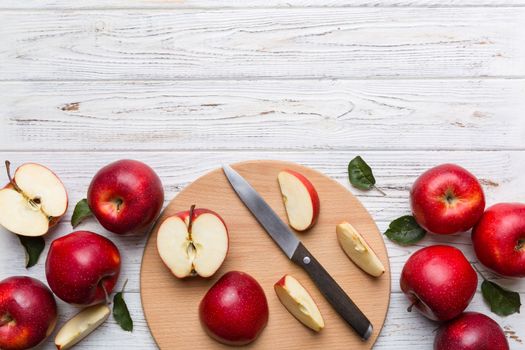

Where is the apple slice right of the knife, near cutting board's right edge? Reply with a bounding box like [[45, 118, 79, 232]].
[[336, 222, 385, 277]]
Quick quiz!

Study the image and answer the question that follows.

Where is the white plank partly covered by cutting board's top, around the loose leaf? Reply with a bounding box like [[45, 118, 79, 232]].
[[2, 151, 525, 222]]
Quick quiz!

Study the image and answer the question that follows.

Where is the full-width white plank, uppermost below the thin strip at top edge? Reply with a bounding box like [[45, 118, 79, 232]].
[[0, 7, 525, 80]]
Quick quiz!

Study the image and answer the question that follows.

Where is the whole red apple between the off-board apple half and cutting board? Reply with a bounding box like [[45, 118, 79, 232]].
[[87, 159, 164, 234]]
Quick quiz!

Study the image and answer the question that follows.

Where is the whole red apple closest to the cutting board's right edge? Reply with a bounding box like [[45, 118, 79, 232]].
[[400, 245, 478, 321]]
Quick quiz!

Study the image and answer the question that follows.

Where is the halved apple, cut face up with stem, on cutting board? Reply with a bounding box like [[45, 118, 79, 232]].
[[157, 207, 228, 278]]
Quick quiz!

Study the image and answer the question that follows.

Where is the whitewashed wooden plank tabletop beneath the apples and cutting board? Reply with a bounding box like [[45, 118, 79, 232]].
[[0, 0, 525, 350]]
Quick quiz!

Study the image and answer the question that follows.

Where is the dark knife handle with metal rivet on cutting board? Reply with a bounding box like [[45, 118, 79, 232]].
[[292, 243, 373, 340]]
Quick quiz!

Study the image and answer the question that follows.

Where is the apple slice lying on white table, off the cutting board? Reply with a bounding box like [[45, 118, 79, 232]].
[[55, 304, 111, 350]]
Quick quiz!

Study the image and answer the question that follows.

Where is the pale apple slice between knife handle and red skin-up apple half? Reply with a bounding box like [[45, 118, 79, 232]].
[[274, 275, 324, 332]]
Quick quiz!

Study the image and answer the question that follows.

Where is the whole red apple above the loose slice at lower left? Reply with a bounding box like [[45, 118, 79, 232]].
[[46, 231, 121, 306]]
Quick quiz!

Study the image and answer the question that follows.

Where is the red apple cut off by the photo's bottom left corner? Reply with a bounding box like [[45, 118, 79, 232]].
[[0, 276, 57, 350]]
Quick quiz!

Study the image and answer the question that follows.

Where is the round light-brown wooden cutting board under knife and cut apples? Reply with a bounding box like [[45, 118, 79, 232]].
[[140, 161, 390, 350]]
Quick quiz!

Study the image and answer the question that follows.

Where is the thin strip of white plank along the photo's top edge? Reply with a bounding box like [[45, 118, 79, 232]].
[[0, 0, 525, 9]]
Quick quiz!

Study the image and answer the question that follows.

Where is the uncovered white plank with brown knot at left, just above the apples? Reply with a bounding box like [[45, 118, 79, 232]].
[[0, 79, 525, 151]]
